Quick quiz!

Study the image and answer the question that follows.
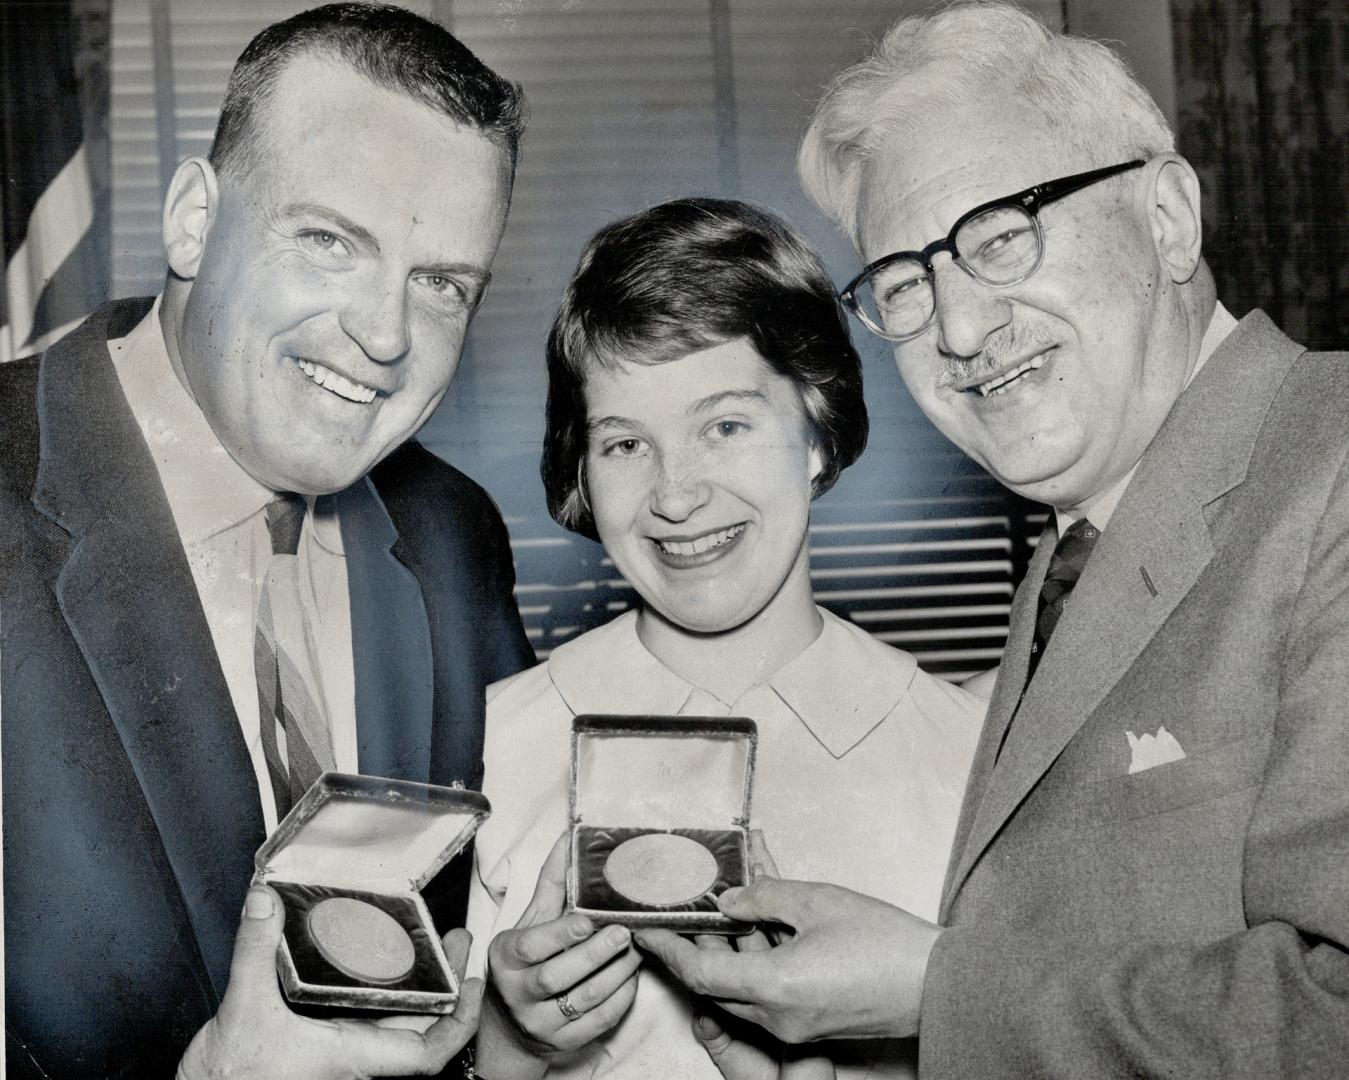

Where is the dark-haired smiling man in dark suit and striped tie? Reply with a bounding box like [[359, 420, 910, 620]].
[[0, 4, 533, 1077]]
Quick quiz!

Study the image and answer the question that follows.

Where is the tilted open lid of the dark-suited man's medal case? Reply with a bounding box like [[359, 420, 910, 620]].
[[255, 773, 491, 891]]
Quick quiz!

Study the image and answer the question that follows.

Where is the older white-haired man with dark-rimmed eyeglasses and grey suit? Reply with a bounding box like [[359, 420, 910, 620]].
[[638, 4, 1349, 1080]]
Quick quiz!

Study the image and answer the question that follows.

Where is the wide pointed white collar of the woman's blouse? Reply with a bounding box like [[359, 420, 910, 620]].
[[548, 608, 917, 758]]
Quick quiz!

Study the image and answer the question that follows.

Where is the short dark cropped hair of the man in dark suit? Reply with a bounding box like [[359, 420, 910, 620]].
[[209, 4, 525, 173]]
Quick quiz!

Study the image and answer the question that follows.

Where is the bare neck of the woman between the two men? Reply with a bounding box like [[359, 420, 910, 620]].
[[637, 545, 824, 704]]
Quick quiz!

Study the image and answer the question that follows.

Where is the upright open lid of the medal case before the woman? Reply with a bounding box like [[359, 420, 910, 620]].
[[571, 716, 758, 829]]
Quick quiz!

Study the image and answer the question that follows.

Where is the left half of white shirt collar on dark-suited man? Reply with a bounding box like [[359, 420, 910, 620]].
[[108, 298, 274, 546]]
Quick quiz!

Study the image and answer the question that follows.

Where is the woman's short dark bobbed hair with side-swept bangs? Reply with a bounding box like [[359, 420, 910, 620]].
[[541, 198, 867, 539]]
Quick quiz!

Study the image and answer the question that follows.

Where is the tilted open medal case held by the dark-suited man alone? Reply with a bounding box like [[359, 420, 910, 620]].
[[254, 773, 491, 1014]]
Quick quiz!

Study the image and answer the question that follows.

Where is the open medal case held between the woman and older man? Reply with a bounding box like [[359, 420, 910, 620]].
[[567, 716, 758, 934]]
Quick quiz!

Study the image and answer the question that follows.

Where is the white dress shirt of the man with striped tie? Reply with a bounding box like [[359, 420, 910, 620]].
[[108, 299, 357, 832]]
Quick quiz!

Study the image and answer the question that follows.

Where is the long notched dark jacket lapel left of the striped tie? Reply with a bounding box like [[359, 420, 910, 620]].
[[34, 305, 263, 995]]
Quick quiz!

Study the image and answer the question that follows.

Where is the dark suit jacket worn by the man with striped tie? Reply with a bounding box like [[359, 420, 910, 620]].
[[0, 301, 533, 1077]]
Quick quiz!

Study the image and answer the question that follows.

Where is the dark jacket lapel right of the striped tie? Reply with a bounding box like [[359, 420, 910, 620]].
[[333, 480, 434, 783]]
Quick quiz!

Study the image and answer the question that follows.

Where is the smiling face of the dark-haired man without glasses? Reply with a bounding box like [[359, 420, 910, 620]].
[[165, 55, 510, 493]]
